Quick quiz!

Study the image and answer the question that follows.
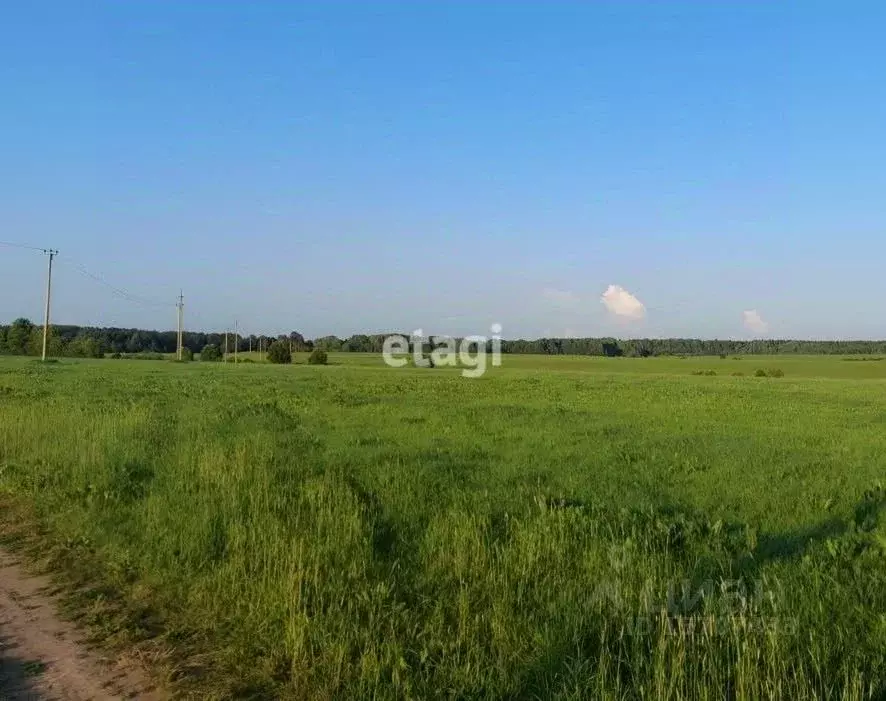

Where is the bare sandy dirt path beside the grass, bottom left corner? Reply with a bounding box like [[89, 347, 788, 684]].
[[0, 551, 168, 701]]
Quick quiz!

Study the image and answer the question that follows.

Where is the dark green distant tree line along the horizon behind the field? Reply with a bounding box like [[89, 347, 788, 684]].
[[0, 319, 886, 358]]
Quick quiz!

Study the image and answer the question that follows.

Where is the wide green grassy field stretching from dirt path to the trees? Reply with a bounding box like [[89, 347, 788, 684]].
[[0, 354, 886, 699]]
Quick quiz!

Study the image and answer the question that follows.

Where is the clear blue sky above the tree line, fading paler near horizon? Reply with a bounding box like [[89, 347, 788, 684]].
[[0, 0, 886, 338]]
